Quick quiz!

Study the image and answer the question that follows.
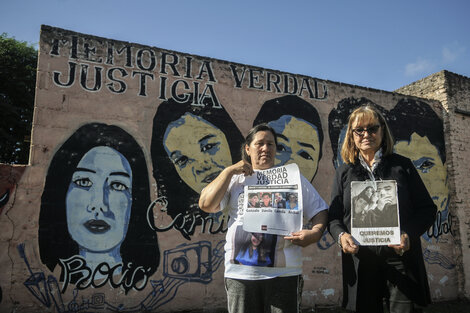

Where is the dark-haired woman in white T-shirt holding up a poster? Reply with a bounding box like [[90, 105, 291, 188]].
[[199, 124, 328, 313]]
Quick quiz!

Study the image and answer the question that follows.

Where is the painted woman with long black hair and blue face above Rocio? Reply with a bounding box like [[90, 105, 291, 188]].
[[39, 123, 160, 288]]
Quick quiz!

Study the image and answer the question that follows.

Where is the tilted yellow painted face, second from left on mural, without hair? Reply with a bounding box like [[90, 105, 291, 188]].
[[163, 113, 232, 193]]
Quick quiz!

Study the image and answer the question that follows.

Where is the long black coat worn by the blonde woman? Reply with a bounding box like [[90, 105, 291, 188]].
[[328, 154, 437, 311]]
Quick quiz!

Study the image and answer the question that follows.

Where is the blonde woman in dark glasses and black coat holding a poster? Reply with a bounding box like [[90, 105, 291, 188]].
[[328, 105, 436, 313]]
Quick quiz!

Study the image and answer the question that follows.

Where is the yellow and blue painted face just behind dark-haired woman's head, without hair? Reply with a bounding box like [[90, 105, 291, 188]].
[[269, 115, 320, 181]]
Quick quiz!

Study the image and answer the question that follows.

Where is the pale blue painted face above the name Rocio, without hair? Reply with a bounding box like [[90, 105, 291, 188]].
[[65, 146, 132, 252]]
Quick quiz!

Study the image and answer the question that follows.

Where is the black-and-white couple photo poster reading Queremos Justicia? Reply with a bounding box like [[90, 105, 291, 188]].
[[351, 180, 400, 246]]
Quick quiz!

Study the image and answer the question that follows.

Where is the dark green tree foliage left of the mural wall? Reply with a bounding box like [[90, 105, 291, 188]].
[[0, 33, 38, 164]]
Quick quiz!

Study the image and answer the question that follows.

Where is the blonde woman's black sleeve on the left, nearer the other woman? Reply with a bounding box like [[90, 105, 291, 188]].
[[328, 167, 349, 240]]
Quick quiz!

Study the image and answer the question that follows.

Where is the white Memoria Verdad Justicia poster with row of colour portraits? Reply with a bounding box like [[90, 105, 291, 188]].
[[243, 164, 302, 236]]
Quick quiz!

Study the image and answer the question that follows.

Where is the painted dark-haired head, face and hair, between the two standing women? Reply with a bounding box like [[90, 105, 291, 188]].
[[253, 95, 323, 182]]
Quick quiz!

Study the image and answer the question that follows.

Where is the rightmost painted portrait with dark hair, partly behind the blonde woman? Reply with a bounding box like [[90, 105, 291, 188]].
[[390, 98, 449, 237]]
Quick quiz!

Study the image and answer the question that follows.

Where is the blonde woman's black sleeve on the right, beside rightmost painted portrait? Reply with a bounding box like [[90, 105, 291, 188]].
[[404, 159, 437, 237]]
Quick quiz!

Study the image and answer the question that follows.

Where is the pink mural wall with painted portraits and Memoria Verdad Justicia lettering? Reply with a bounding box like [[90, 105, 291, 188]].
[[0, 26, 458, 312]]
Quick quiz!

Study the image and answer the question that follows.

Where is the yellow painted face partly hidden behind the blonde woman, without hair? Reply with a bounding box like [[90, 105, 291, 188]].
[[394, 133, 449, 211]]
